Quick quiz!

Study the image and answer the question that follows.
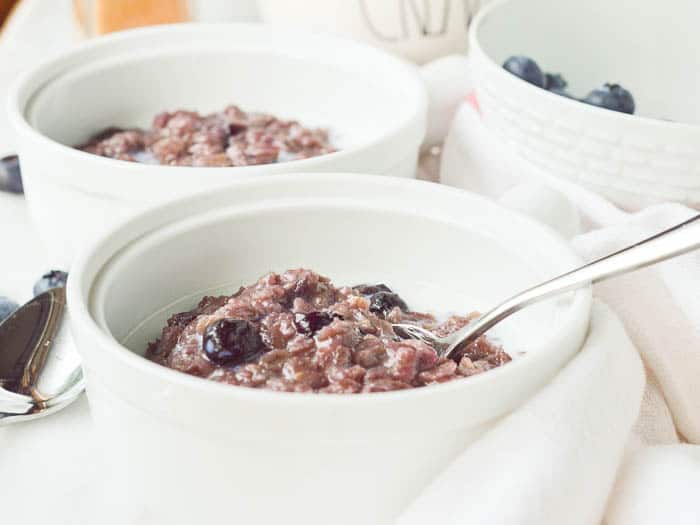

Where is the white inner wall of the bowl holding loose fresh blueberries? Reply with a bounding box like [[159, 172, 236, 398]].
[[476, 0, 700, 124]]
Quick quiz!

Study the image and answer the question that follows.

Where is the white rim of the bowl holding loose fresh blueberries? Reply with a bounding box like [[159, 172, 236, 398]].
[[468, 0, 700, 132]]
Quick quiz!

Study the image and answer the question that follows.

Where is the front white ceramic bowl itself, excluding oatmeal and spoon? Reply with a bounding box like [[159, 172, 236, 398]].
[[68, 174, 590, 525]]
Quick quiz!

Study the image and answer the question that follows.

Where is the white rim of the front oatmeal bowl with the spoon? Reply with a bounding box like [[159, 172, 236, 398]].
[[67, 172, 592, 408]]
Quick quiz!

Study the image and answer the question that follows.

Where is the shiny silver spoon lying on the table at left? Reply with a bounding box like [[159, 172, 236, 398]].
[[0, 288, 85, 426]]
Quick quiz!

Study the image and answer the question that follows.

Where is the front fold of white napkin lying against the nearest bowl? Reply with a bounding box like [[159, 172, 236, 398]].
[[398, 303, 644, 525]]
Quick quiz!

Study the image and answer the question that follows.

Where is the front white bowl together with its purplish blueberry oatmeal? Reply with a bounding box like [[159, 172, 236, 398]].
[[68, 173, 590, 524]]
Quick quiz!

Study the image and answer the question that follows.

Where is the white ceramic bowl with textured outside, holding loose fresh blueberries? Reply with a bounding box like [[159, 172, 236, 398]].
[[470, 0, 700, 208]]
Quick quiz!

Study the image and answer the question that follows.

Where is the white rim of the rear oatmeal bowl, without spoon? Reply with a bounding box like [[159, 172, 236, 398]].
[[6, 22, 428, 176]]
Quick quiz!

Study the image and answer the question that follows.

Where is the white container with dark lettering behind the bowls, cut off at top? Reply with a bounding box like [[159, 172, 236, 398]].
[[258, 0, 484, 64]]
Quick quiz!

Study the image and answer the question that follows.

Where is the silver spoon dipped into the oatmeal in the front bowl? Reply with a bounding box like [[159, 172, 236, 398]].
[[393, 215, 700, 357]]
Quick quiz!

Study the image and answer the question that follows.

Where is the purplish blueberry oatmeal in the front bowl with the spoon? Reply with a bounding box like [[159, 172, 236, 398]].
[[146, 269, 511, 394]]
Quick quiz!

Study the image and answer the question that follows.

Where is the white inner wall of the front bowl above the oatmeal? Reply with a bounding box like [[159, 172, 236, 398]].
[[91, 176, 587, 357]]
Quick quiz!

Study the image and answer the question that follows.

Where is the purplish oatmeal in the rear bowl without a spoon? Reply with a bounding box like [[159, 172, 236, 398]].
[[77, 106, 336, 166]]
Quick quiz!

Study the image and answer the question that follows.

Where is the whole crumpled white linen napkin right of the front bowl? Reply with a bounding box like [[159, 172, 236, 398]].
[[408, 52, 700, 525]]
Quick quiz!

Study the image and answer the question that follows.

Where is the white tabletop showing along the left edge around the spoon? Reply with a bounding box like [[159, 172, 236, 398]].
[[0, 0, 252, 525]]
